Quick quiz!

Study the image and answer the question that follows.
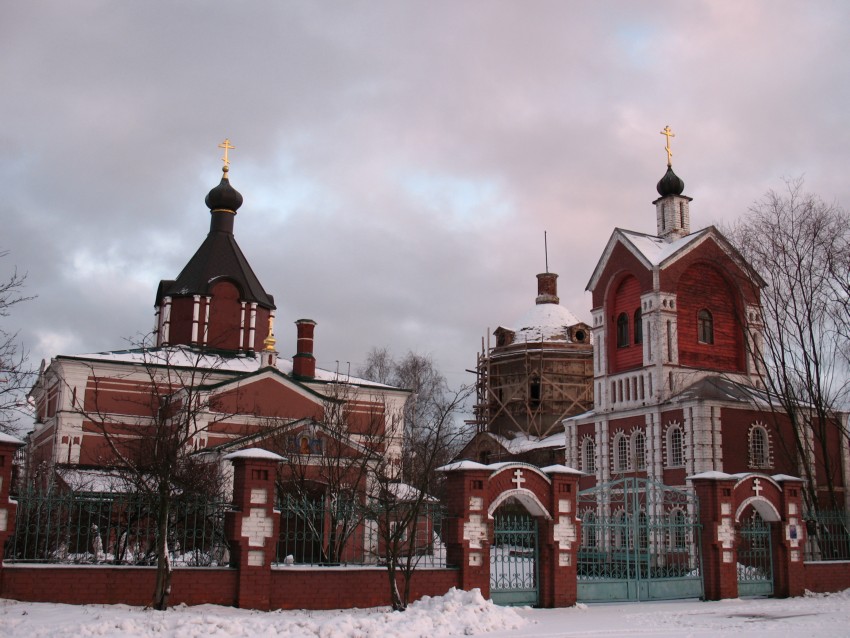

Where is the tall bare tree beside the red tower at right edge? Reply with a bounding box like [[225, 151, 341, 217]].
[[727, 179, 850, 508]]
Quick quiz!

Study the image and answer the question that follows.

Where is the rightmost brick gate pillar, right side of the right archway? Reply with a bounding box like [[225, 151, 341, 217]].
[[771, 477, 806, 598]]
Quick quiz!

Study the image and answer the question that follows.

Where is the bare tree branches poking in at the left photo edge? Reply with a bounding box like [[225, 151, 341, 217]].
[[0, 251, 33, 433]]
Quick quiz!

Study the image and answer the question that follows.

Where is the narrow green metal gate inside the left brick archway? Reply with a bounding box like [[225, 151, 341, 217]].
[[490, 511, 539, 605]]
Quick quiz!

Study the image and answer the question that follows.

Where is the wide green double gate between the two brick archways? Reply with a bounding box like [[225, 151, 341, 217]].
[[578, 478, 703, 602]]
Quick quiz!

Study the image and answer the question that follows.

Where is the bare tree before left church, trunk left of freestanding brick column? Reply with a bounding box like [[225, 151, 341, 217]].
[[65, 341, 238, 610]]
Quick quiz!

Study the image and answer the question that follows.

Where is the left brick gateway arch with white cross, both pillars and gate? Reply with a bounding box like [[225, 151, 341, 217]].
[[441, 461, 580, 607]]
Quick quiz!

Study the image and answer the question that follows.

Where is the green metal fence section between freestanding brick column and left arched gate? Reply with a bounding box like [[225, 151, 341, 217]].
[[275, 495, 447, 567]]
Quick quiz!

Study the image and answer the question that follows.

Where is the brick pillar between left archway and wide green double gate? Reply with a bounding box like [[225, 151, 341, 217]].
[[540, 465, 581, 607]]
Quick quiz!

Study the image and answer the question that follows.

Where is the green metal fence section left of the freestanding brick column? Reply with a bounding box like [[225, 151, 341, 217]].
[[5, 489, 230, 567]]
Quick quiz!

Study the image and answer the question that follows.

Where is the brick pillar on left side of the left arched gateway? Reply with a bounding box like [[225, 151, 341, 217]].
[[441, 461, 492, 598]]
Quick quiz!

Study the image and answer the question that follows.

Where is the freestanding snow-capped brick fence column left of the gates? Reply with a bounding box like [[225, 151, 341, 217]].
[[224, 449, 284, 610]]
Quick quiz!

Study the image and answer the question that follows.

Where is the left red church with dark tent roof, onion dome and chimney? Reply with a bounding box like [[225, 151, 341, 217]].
[[25, 158, 409, 488]]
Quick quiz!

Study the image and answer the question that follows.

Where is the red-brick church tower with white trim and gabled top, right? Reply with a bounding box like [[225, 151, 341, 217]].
[[564, 158, 850, 507]]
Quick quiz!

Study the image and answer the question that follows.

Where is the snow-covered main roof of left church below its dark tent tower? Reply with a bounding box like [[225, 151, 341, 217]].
[[61, 346, 398, 390]]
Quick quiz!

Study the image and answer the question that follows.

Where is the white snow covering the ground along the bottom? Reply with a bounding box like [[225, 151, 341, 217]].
[[0, 590, 850, 638]]
